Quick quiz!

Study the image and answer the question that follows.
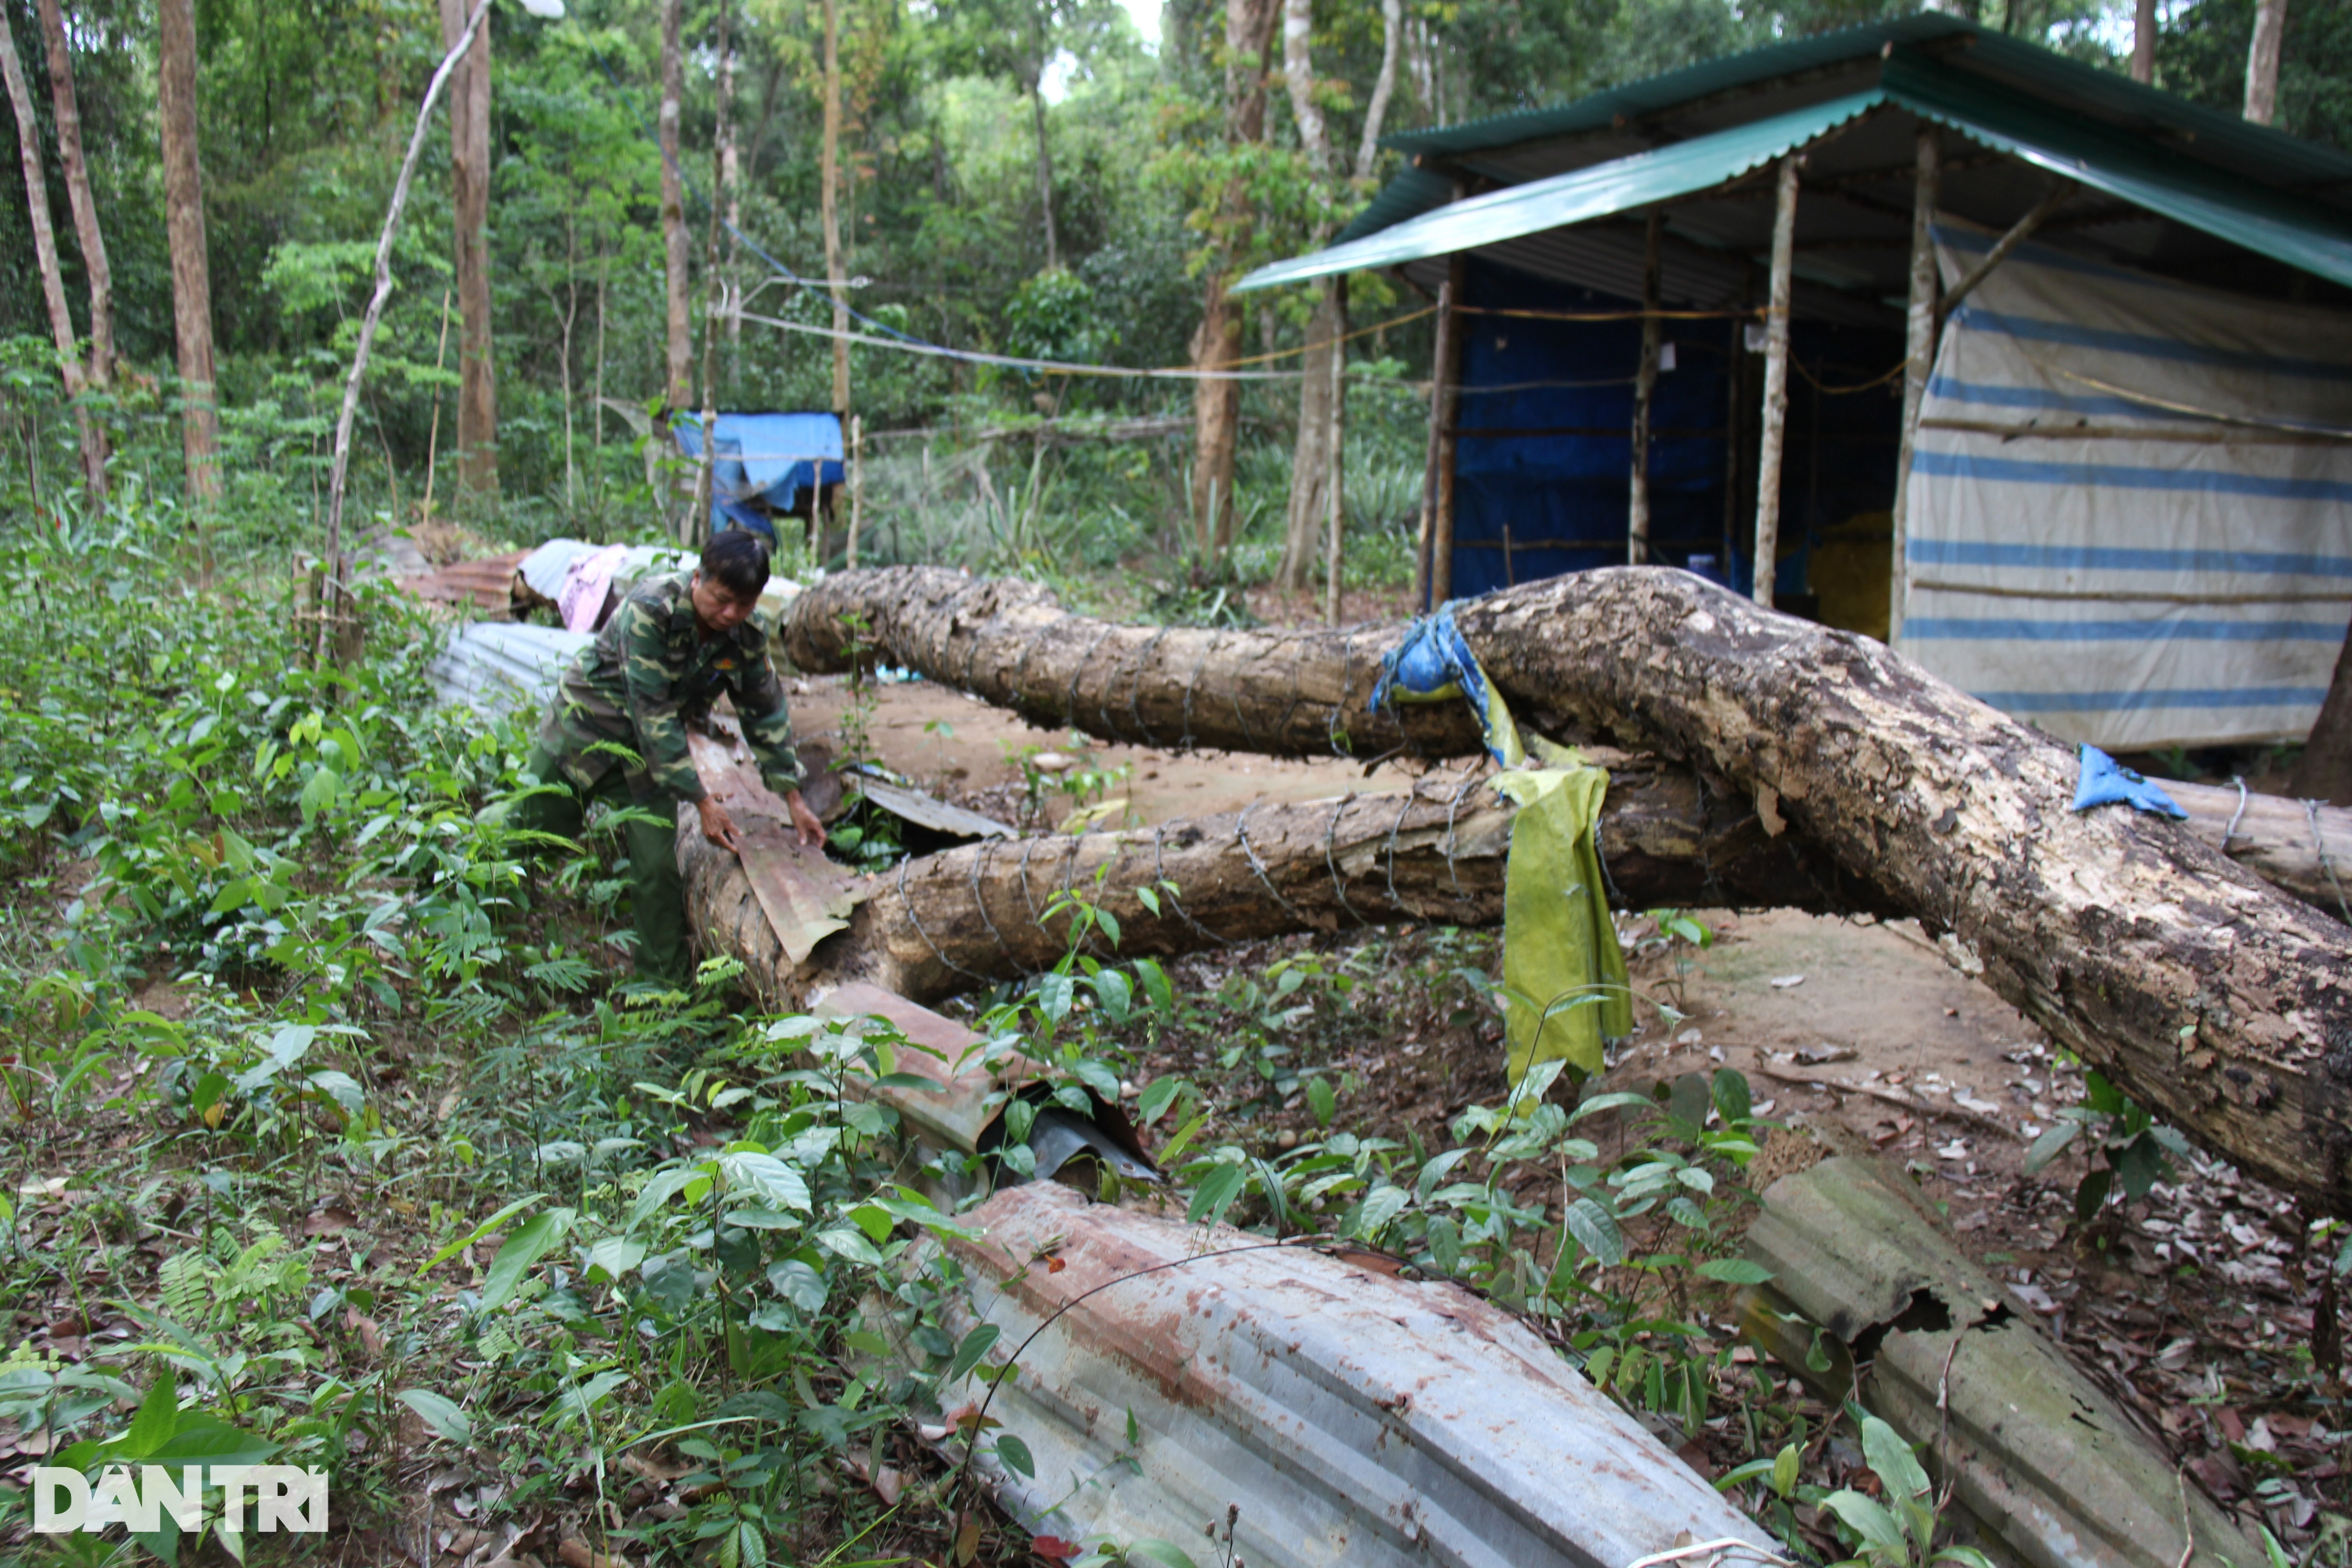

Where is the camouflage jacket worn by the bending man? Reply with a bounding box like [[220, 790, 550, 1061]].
[[539, 571, 800, 802]]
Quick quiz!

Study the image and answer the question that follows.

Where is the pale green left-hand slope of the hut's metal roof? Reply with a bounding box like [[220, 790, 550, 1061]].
[[1232, 92, 1884, 294]]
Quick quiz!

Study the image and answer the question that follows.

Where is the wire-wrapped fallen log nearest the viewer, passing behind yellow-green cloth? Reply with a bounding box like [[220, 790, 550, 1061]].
[[680, 755, 1884, 1006]]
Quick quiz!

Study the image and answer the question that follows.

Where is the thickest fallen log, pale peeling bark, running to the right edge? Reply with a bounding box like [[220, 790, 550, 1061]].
[[1458, 566, 2352, 1213]]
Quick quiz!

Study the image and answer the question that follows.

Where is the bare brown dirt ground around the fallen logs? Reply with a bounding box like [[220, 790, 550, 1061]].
[[793, 679, 2352, 1561]]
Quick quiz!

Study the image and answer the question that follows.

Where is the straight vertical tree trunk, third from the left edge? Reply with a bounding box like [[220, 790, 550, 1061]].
[[155, 0, 221, 501]]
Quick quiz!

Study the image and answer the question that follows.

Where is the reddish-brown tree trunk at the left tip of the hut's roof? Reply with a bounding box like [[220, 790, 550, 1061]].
[[1192, 0, 1279, 569]]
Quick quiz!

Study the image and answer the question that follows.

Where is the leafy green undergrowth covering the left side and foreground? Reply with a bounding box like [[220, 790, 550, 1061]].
[[0, 505, 1976, 1568]]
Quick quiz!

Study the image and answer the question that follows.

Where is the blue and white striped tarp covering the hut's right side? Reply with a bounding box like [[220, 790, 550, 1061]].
[[1900, 223, 2352, 750]]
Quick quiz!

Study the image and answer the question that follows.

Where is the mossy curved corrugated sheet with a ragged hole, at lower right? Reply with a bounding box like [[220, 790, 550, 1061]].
[[1745, 1157, 2263, 1568]]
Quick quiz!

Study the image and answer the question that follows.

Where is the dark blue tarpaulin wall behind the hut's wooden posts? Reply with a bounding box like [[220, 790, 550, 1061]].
[[1454, 259, 1903, 597]]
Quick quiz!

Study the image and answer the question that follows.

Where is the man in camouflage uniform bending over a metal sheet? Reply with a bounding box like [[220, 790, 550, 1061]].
[[515, 529, 826, 985]]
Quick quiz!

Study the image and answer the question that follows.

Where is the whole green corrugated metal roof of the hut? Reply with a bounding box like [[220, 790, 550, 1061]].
[[1235, 39, 2352, 292]]
